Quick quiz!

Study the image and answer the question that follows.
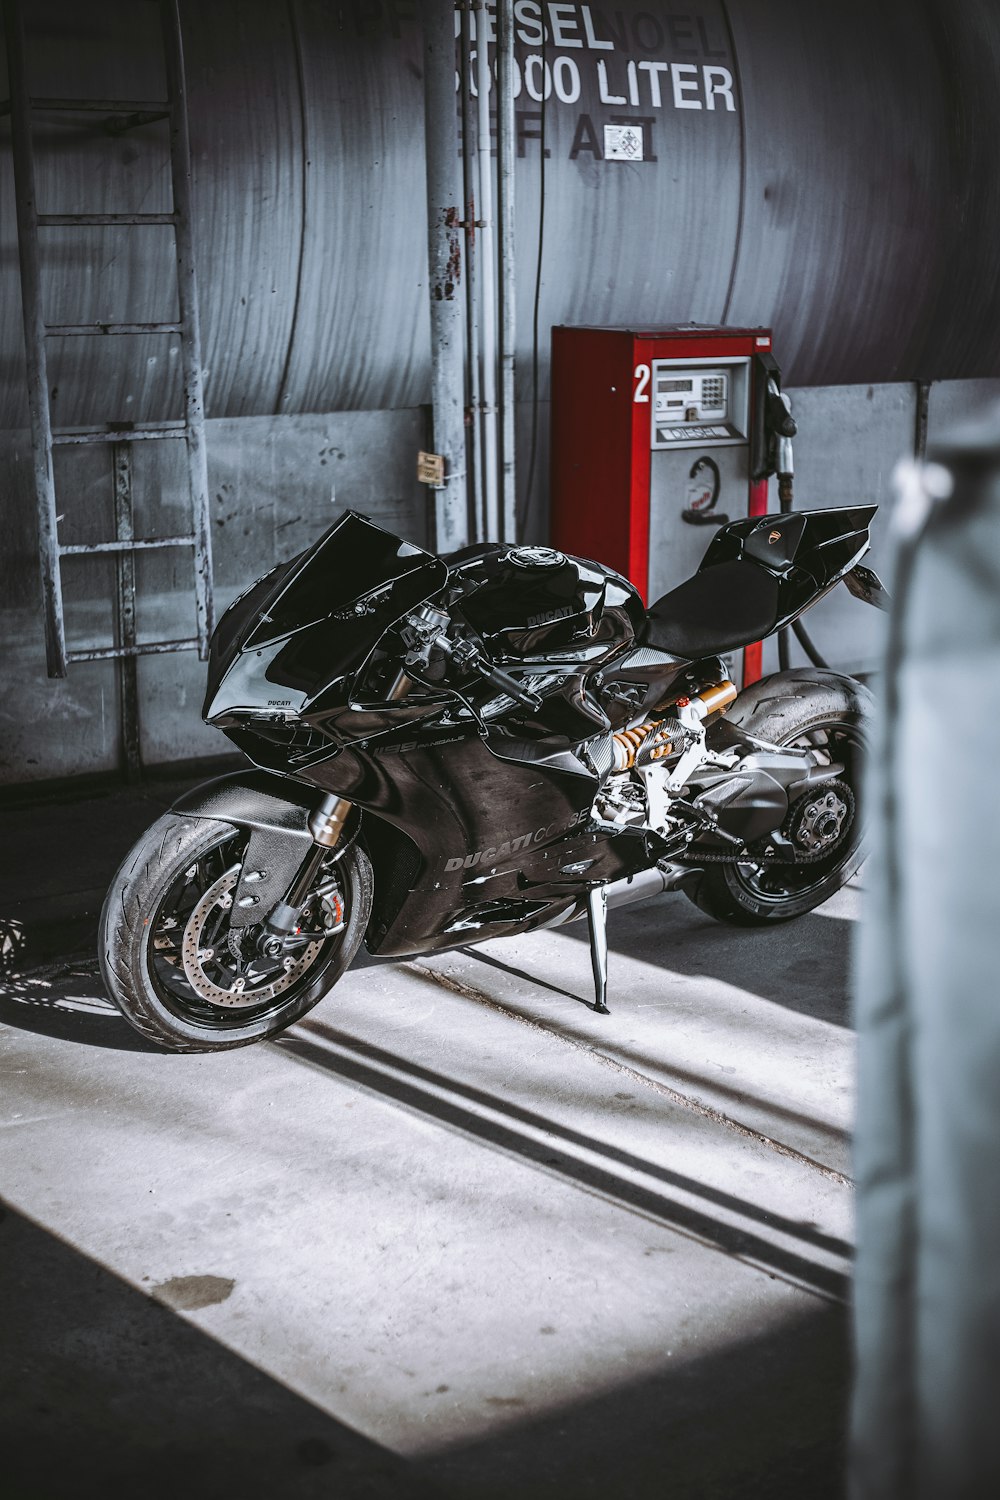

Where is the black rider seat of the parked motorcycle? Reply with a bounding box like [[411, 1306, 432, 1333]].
[[643, 561, 780, 662]]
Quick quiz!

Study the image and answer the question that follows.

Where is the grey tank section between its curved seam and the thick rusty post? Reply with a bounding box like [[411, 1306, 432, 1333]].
[[280, 0, 430, 411]]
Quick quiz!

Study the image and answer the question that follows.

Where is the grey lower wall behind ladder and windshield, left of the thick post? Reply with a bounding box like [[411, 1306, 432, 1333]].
[[0, 408, 427, 785]]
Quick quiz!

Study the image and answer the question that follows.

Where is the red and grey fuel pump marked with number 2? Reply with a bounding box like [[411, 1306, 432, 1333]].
[[552, 324, 781, 684]]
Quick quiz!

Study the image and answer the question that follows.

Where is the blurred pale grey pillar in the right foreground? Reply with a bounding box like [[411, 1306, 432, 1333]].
[[852, 419, 1000, 1500]]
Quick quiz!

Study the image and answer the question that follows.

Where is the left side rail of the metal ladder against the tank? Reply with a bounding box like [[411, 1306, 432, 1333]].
[[3, 0, 66, 677]]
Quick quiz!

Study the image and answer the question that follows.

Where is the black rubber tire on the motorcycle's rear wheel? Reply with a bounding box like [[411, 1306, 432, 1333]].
[[685, 668, 874, 927]]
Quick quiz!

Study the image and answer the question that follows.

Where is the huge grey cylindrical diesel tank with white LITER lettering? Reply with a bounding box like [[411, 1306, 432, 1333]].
[[0, 0, 1000, 428]]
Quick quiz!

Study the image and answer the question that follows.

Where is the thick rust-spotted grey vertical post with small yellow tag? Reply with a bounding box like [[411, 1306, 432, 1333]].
[[421, 0, 469, 552]]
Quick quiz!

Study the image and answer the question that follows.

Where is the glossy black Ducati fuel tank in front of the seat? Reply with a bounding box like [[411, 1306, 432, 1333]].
[[448, 546, 645, 663]]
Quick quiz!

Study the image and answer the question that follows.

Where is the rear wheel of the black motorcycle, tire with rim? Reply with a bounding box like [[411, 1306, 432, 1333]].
[[687, 668, 873, 927]]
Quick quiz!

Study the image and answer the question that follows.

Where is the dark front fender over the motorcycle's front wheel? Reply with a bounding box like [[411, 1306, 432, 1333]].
[[172, 771, 361, 927]]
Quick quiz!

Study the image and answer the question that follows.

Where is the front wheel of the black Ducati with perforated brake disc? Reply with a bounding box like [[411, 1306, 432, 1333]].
[[99, 813, 372, 1052]]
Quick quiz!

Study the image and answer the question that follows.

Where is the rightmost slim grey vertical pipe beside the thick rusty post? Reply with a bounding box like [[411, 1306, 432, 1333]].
[[496, 0, 515, 542]]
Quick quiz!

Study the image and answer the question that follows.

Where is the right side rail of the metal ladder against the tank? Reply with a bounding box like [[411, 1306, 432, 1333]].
[[160, 0, 216, 662]]
